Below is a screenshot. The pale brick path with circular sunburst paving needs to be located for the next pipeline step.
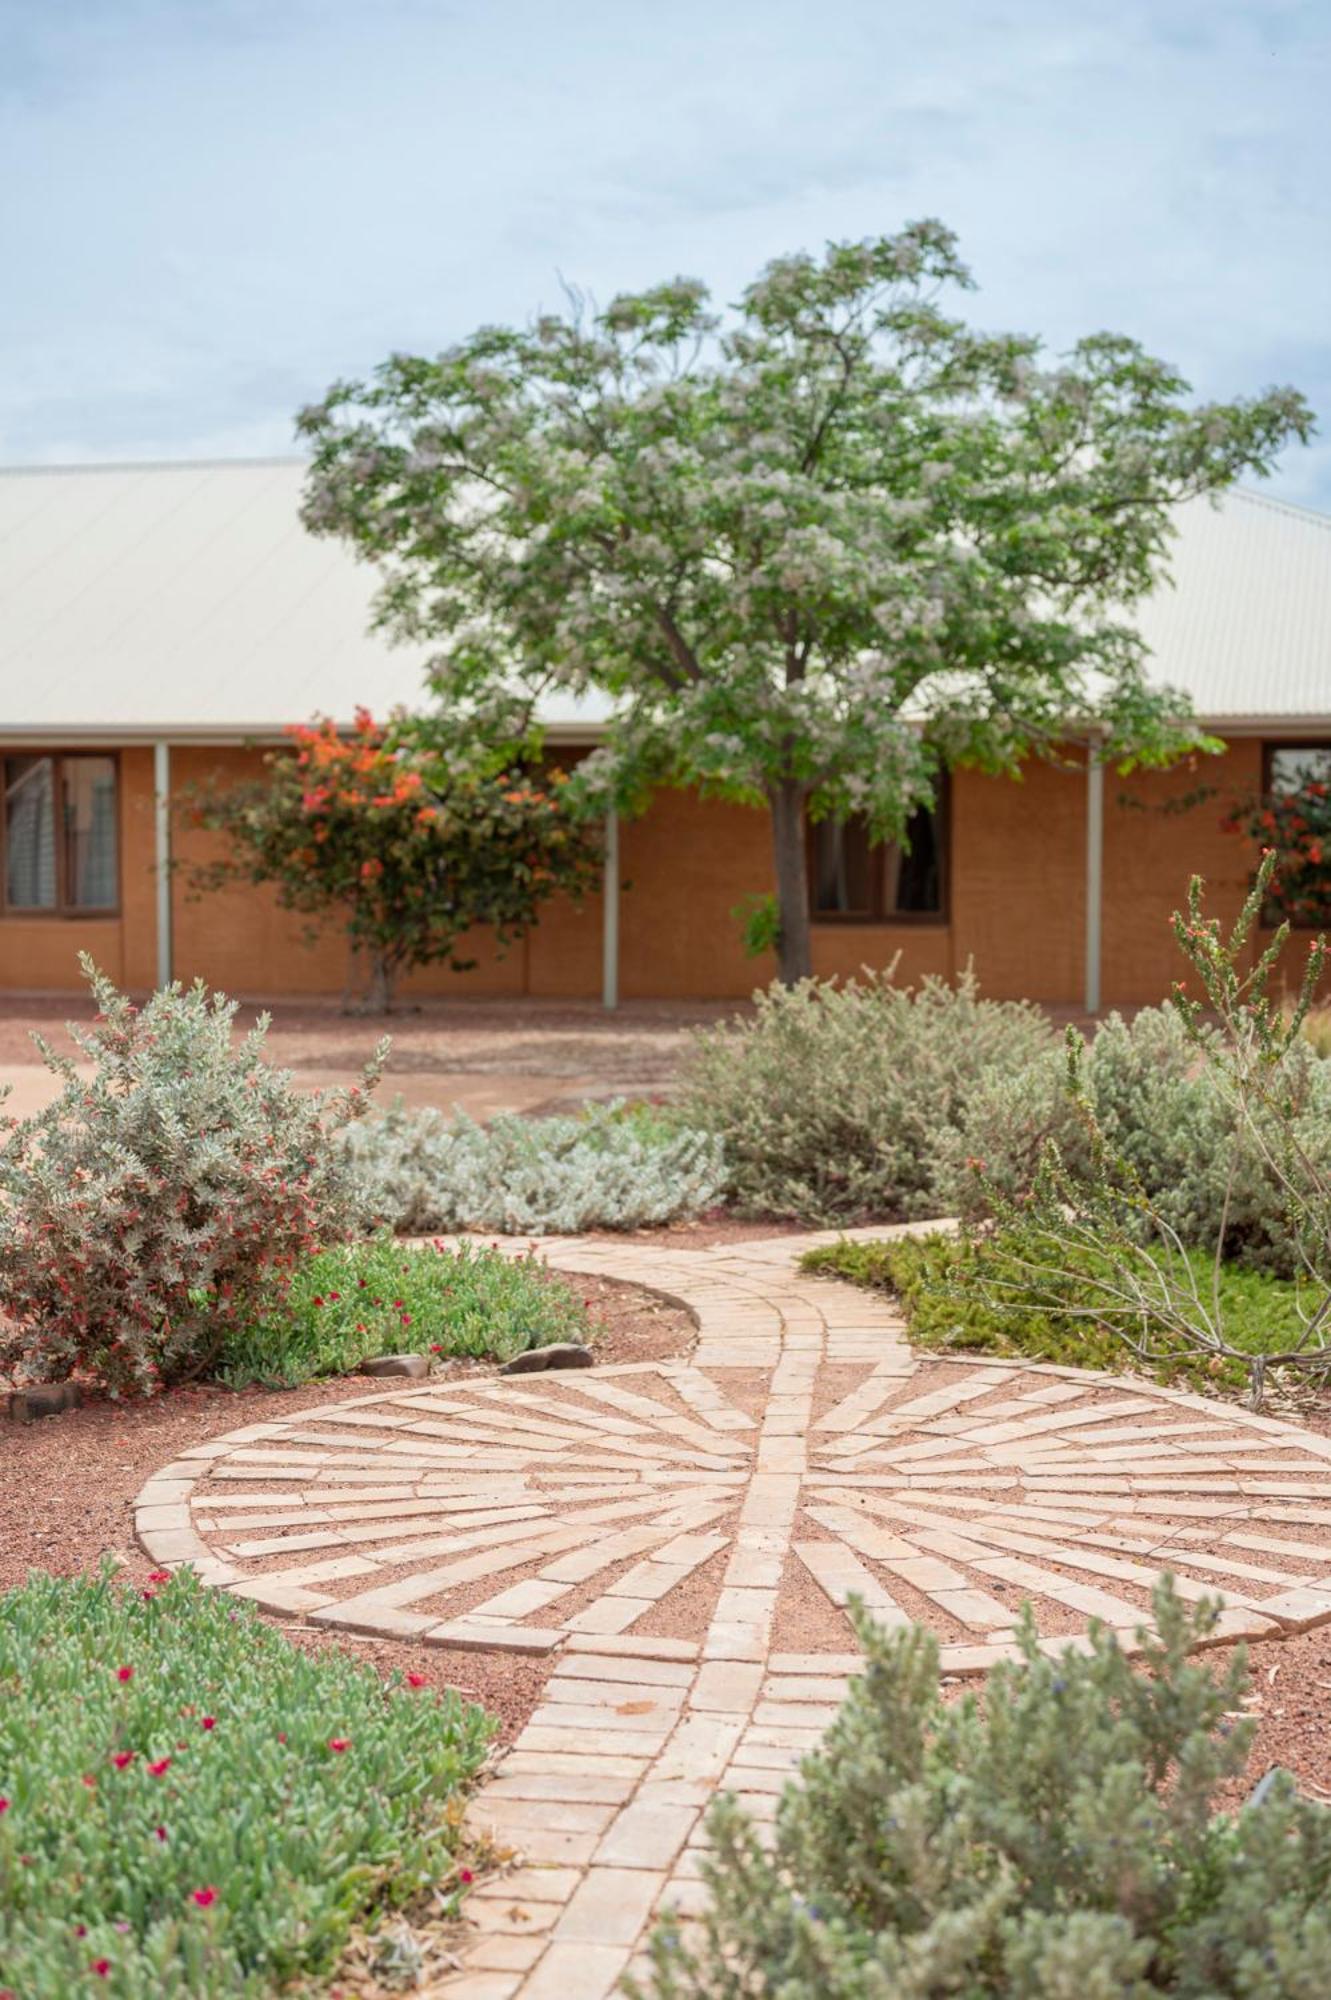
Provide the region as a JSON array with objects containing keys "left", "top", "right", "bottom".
[{"left": 129, "top": 1230, "right": 1331, "bottom": 2000}]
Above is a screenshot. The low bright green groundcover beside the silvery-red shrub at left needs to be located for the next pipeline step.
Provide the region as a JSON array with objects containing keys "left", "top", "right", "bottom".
[{"left": 216, "top": 1236, "right": 592, "bottom": 1388}]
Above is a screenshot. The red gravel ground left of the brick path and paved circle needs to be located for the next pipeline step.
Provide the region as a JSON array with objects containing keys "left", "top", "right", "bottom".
[{"left": 0, "top": 1278, "right": 695, "bottom": 1742}]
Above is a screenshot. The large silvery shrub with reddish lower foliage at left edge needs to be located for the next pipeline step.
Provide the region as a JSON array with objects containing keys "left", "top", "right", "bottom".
[{"left": 0, "top": 958, "right": 384, "bottom": 1396}]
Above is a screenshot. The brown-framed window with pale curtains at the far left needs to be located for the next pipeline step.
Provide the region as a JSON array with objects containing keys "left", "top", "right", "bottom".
[{"left": 4, "top": 752, "right": 120, "bottom": 916}]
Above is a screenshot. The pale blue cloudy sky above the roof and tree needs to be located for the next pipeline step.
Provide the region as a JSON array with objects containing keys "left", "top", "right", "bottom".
[{"left": 0, "top": 0, "right": 1331, "bottom": 512}]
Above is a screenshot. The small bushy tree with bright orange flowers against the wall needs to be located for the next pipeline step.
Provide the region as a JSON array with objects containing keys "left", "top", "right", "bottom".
[{"left": 190, "top": 708, "right": 596, "bottom": 1014}]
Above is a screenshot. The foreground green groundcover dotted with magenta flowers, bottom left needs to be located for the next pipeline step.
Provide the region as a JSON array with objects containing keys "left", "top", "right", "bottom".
[{"left": 0, "top": 1574, "right": 492, "bottom": 2000}]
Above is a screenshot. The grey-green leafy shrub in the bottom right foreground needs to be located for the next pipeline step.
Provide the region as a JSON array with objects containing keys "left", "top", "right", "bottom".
[{"left": 631, "top": 1580, "right": 1331, "bottom": 2000}]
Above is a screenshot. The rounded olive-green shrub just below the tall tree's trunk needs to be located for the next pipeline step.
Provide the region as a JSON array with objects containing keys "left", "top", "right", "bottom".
[{"left": 681, "top": 972, "right": 1053, "bottom": 1224}]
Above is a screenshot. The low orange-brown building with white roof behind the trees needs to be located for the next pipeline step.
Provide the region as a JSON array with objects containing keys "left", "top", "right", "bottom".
[{"left": 0, "top": 460, "right": 1331, "bottom": 1012}]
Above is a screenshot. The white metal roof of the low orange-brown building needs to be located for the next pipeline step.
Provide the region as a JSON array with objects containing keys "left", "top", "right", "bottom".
[{"left": 0, "top": 460, "right": 1331, "bottom": 740}]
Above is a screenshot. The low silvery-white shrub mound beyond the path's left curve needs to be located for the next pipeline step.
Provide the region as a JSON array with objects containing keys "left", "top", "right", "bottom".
[{"left": 342, "top": 1104, "right": 725, "bottom": 1236}]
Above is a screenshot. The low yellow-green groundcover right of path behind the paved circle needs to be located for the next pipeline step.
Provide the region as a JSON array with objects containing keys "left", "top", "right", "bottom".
[{"left": 801, "top": 1228, "right": 1303, "bottom": 1390}]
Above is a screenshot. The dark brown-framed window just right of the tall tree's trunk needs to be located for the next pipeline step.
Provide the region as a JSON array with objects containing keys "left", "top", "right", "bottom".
[{"left": 809, "top": 800, "right": 945, "bottom": 924}]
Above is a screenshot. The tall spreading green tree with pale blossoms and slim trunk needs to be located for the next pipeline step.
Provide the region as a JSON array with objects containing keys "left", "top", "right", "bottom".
[{"left": 300, "top": 222, "right": 1311, "bottom": 980}]
